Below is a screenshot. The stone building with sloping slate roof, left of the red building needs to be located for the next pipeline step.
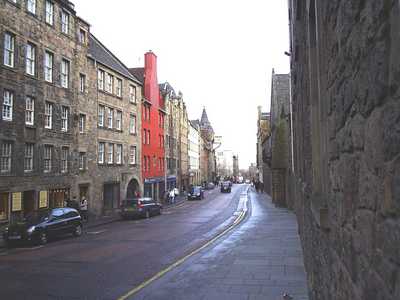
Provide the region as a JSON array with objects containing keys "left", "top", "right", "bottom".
[{"left": 74, "top": 33, "right": 143, "bottom": 215}]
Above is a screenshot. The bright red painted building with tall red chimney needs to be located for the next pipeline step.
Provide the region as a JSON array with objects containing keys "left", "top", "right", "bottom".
[{"left": 130, "top": 51, "right": 166, "bottom": 199}]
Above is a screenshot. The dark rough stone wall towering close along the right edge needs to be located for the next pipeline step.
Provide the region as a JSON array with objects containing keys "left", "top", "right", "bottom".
[{"left": 289, "top": 0, "right": 400, "bottom": 300}]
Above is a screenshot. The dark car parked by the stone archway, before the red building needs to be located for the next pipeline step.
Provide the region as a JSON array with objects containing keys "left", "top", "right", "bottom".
[{"left": 121, "top": 197, "right": 162, "bottom": 219}]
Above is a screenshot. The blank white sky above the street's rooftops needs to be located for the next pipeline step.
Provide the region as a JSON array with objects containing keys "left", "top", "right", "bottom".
[{"left": 72, "top": 0, "right": 289, "bottom": 168}]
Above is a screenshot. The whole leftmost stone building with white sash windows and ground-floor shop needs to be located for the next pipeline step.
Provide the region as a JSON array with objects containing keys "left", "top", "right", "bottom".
[{"left": 0, "top": 0, "right": 81, "bottom": 223}]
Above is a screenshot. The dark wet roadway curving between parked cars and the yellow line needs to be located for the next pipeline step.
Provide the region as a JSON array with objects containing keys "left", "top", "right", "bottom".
[{"left": 0, "top": 185, "right": 246, "bottom": 300}]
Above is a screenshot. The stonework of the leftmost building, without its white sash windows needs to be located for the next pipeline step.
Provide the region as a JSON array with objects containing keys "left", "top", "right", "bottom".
[{"left": 0, "top": 1, "right": 76, "bottom": 220}]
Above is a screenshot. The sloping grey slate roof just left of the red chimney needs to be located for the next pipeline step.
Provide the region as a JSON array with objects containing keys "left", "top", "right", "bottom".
[{"left": 89, "top": 34, "right": 140, "bottom": 83}]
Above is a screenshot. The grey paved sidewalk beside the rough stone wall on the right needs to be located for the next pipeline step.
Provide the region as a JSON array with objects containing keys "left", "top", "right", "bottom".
[{"left": 130, "top": 192, "right": 308, "bottom": 300}]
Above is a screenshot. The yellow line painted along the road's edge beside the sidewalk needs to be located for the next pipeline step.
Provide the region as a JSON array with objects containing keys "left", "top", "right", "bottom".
[{"left": 118, "top": 211, "right": 246, "bottom": 300}]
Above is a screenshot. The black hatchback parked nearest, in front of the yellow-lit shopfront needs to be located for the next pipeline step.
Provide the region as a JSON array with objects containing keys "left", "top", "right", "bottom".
[{"left": 3, "top": 207, "right": 82, "bottom": 245}]
